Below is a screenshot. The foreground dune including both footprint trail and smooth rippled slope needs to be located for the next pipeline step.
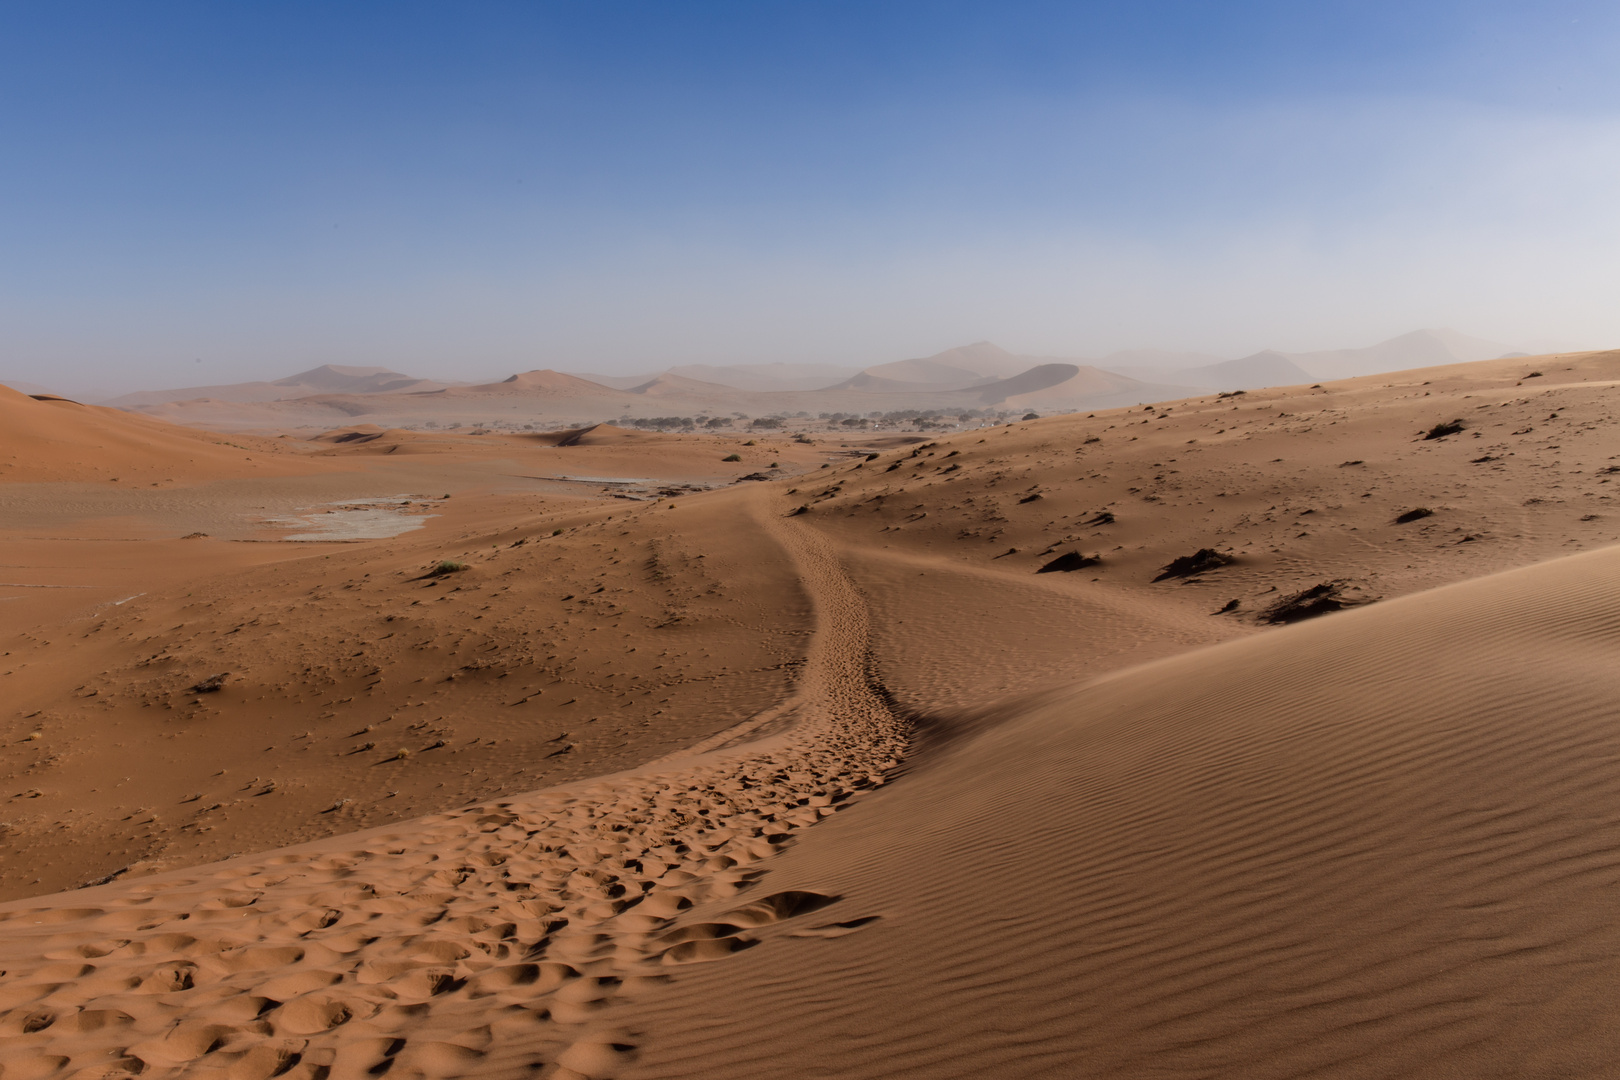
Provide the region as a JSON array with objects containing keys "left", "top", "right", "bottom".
[{"left": 9, "top": 525, "right": 1620, "bottom": 1080}]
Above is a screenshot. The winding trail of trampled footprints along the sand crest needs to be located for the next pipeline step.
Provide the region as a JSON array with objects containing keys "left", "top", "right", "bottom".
[{"left": 0, "top": 499, "right": 907, "bottom": 1080}]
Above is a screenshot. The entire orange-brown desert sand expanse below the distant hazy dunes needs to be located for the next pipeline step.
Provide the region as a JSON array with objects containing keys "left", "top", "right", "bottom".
[{"left": 0, "top": 353, "right": 1620, "bottom": 1080}]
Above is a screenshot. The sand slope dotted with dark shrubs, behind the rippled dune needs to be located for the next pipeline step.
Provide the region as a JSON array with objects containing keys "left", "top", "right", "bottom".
[{"left": 787, "top": 353, "right": 1620, "bottom": 711}]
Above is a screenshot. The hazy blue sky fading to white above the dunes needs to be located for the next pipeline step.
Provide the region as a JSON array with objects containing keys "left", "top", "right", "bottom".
[{"left": 0, "top": 0, "right": 1620, "bottom": 390}]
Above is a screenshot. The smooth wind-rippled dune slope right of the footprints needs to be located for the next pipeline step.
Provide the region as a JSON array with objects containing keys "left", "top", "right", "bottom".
[{"left": 612, "top": 549, "right": 1620, "bottom": 1077}]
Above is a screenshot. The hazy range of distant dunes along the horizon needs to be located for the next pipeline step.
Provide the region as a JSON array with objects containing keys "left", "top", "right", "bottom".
[{"left": 101, "top": 330, "right": 1542, "bottom": 431}]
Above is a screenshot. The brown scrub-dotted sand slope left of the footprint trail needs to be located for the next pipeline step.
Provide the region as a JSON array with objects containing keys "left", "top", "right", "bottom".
[{"left": 0, "top": 484, "right": 810, "bottom": 895}]
